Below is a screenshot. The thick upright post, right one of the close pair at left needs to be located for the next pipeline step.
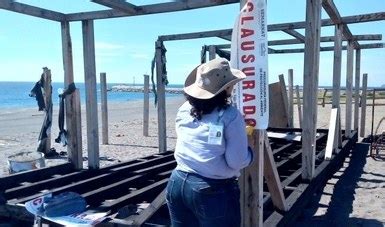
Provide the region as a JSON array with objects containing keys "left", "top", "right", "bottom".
[{"left": 82, "top": 20, "right": 99, "bottom": 169}]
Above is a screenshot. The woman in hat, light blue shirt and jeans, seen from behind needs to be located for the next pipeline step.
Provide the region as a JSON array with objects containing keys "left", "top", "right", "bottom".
[{"left": 166, "top": 58, "right": 253, "bottom": 227}]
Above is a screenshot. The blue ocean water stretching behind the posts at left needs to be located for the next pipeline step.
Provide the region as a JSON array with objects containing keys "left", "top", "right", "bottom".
[{"left": 0, "top": 82, "right": 181, "bottom": 109}]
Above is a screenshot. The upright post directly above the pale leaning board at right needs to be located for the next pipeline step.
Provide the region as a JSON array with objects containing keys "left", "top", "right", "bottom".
[{"left": 332, "top": 24, "right": 342, "bottom": 108}]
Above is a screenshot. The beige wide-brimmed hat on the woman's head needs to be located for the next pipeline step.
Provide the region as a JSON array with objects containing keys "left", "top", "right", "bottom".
[{"left": 184, "top": 58, "right": 246, "bottom": 99}]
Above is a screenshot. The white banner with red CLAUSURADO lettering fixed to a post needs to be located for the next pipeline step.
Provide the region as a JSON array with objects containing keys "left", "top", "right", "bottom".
[{"left": 231, "top": 0, "right": 269, "bottom": 129}]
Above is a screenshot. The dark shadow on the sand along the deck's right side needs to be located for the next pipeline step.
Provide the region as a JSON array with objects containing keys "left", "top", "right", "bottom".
[{"left": 290, "top": 143, "right": 383, "bottom": 227}]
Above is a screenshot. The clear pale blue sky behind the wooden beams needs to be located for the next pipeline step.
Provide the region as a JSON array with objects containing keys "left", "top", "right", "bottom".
[{"left": 0, "top": 0, "right": 385, "bottom": 86}]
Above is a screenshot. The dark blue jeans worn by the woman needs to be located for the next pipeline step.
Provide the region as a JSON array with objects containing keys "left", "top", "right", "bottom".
[{"left": 166, "top": 170, "right": 241, "bottom": 227}]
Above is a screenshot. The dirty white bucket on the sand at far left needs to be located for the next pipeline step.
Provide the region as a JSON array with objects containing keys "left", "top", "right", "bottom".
[{"left": 8, "top": 151, "right": 45, "bottom": 173}]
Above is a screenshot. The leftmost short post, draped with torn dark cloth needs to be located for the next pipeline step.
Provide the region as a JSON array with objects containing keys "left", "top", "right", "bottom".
[{"left": 43, "top": 67, "right": 53, "bottom": 153}]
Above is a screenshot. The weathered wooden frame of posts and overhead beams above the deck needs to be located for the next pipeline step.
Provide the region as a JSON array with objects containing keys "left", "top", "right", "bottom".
[{"left": 0, "top": 0, "right": 385, "bottom": 226}]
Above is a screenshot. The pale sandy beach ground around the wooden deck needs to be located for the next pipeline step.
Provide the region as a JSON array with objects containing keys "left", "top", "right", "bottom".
[{"left": 0, "top": 96, "right": 385, "bottom": 226}]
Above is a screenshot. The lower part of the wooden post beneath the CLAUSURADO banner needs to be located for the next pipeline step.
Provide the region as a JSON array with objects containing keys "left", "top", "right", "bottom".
[{"left": 239, "top": 130, "right": 265, "bottom": 227}]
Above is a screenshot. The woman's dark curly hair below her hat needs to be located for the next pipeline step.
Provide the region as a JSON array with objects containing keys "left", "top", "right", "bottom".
[{"left": 184, "top": 91, "right": 230, "bottom": 120}]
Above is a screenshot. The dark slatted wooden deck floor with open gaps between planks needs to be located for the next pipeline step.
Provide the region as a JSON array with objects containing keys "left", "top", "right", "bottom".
[{"left": 0, "top": 128, "right": 357, "bottom": 226}]
